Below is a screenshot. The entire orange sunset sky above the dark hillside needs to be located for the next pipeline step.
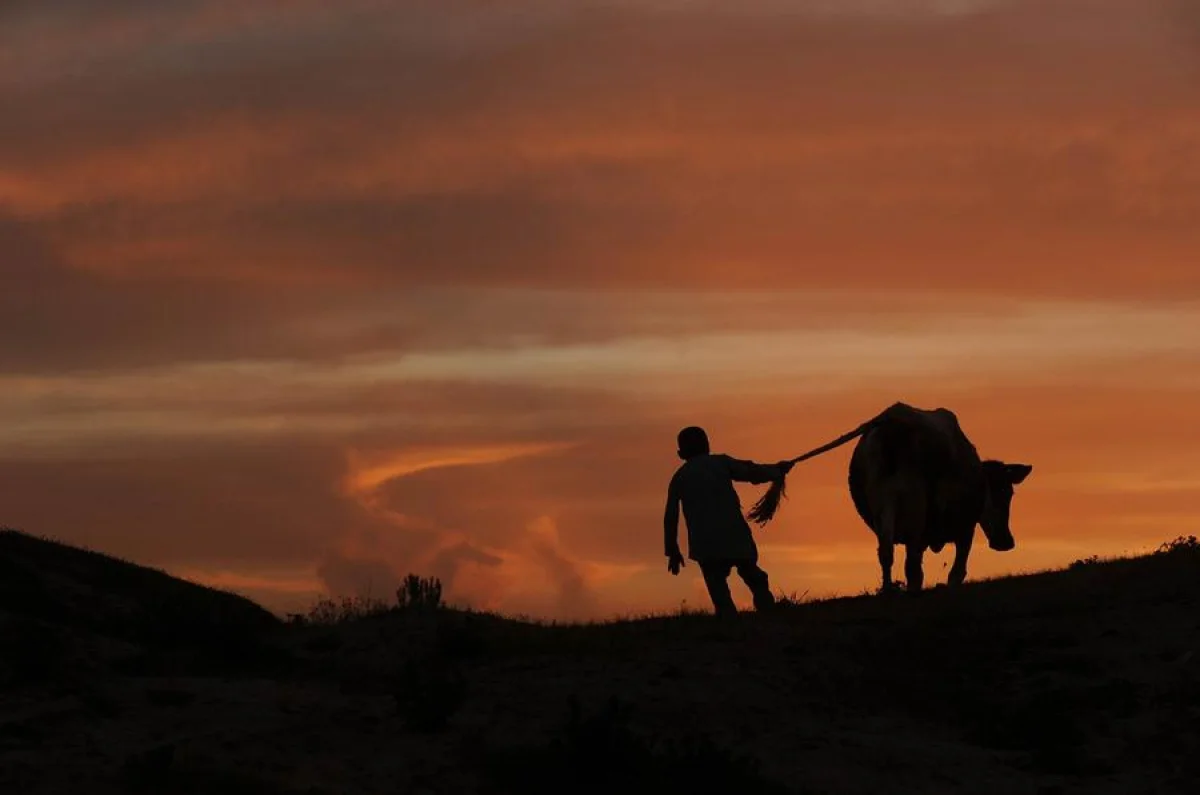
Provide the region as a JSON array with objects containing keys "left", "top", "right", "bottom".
[{"left": 0, "top": 0, "right": 1200, "bottom": 620}]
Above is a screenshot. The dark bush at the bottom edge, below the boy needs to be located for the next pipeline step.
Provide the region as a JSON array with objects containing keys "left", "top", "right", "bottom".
[{"left": 484, "top": 697, "right": 788, "bottom": 795}]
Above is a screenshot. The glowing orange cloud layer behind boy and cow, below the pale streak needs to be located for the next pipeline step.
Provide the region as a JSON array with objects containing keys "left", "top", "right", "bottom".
[{"left": 0, "top": 363, "right": 1200, "bottom": 617}]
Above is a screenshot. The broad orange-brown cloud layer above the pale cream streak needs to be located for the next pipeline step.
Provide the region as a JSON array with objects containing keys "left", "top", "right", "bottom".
[{"left": 0, "top": 2, "right": 1200, "bottom": 302}]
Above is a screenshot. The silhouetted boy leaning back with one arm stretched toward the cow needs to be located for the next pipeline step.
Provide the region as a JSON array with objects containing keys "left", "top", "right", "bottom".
[{"left": 664, "top": 426, "right": 792, "bottom": 615}]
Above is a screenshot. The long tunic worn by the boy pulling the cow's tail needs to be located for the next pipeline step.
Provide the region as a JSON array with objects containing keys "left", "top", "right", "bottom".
[{"left": 664, "top": 453, "right": 782, "bottom": 562}]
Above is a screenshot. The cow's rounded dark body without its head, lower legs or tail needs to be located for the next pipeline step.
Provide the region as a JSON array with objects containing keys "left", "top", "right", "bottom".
[{"left": 850, "top": 404, "right": 983, "bottom": 549}]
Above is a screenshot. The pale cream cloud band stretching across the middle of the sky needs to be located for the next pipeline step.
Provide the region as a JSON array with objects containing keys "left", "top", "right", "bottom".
[{"left": 9, "top": 291, "right": 1198, "bottom": 422}]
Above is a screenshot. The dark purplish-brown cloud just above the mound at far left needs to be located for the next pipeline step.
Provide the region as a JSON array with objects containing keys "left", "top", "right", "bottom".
[{"left": 0, "top": 441, "right": 364, "bottom": 569}]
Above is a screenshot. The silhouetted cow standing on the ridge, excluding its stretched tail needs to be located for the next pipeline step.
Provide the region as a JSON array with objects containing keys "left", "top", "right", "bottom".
[{"left": 844, "top": 402, "right": 1033, "bottom": 593}]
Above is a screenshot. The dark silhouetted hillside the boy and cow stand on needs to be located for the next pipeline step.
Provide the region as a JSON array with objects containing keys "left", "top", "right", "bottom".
[{"left": 0, "top": 528, "right": 1200, "bottom": 795}]
